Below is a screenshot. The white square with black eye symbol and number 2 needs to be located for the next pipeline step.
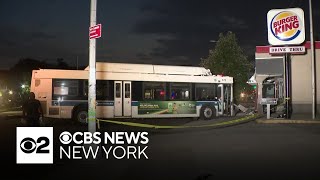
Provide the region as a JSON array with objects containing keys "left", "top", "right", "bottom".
[{"left": 16, "top": 127, "right": 53, "bottom": 164}]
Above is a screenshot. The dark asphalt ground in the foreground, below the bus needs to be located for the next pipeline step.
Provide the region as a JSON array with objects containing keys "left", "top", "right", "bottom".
[{"left": 0, "top": 108, "right": 320, "bottom": 180}]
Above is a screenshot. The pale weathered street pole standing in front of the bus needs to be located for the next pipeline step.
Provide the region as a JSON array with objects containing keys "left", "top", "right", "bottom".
[{"left": 88, "top": 0, "right": 97, "bottom": 133}]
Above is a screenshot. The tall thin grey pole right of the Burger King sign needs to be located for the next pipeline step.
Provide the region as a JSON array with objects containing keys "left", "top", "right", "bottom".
[{"left": 309, "top": 0, "right": 316, "bottom": 119}]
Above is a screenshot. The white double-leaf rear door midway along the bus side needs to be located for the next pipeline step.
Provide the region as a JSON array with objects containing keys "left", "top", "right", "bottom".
[{"left": 114, "top": 81, "right": 131, "bottom": 117}]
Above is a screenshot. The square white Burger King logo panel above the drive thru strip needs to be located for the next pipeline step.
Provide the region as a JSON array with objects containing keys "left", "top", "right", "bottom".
[{"left": 267, "top": 8, "right": 305, "bottom": 45}]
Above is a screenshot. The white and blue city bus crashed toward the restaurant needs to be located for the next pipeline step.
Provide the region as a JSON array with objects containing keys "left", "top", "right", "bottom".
[{"left": 30, "top": 62, "right": 233, "bottom": 123}]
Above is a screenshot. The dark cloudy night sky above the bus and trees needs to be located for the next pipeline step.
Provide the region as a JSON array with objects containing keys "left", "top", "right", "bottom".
[{"left": 0, "top": 0, "right": 320, "bottom": 69}]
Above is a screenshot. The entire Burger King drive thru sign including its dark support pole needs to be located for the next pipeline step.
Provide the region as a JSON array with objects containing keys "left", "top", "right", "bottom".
[{"left": 267, "top": 8, "right": 305, "bottom": 119}]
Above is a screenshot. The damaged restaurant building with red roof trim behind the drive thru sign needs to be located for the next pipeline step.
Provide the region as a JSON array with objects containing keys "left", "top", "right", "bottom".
[{"left": 252, "top": 41, "right": 320, "bottom": 114}]
